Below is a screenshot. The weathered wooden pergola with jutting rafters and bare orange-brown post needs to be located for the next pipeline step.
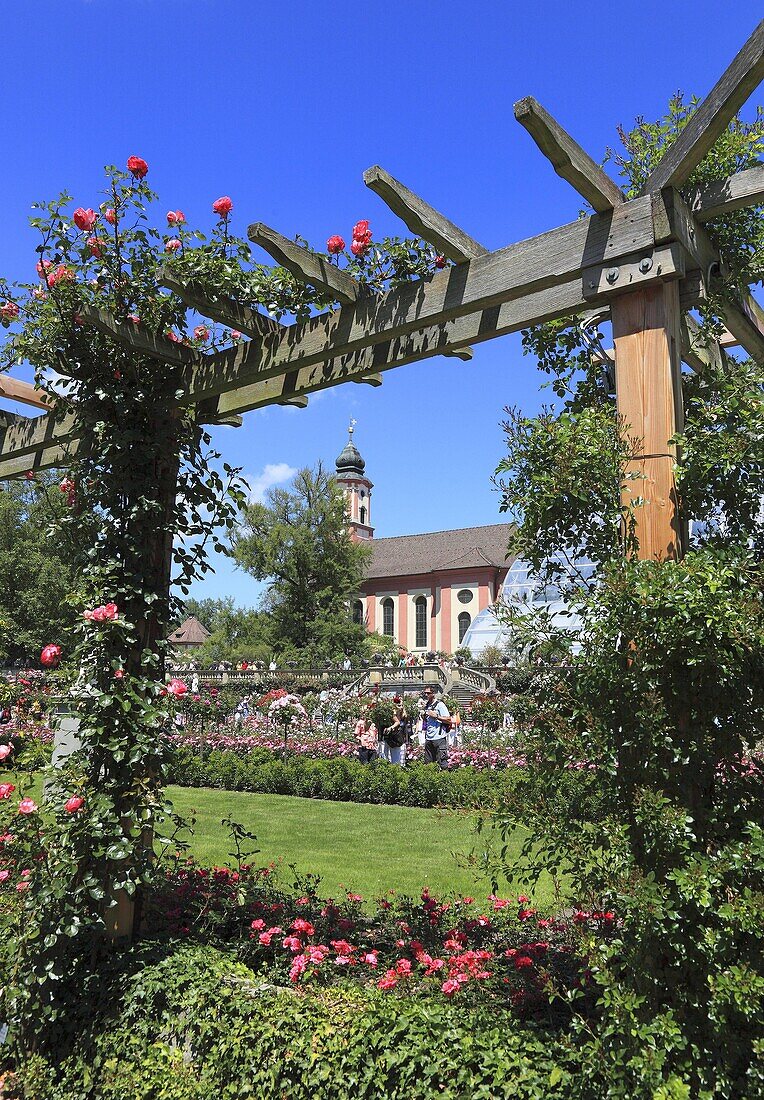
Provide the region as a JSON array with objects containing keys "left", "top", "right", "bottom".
[{"left": 0, "top": 21, "right": 764, "bottom": 560}]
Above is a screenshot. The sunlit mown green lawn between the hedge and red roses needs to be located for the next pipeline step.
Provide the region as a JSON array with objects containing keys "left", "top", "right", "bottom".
[{"left": 13, "top": 780, "right": 553, "bottom": 905}]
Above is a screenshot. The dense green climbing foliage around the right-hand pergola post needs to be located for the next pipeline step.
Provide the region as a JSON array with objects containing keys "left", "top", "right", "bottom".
[{"left": 490, "top": 99, "right": 764, "bottom": 1098}]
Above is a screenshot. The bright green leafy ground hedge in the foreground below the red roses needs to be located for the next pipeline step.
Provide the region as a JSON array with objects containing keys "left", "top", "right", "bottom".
[{"left": 18, "top": 946, "right": 584, "bottom": 1100}]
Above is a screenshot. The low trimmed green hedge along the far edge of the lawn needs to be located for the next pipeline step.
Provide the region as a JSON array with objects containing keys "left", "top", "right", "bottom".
[{"left": 168, "top": 749, "right": 522, "bottom": 810}]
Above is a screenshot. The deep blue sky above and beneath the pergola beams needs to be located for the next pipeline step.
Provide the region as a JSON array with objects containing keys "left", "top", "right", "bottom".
[{"left": 0, "top": 0, "right": 761, "bottom": 604}]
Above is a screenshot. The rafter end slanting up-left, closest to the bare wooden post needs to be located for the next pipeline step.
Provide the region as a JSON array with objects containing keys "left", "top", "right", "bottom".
[{"left": 514, "top": 96, "right": 623, "bottom": 213}]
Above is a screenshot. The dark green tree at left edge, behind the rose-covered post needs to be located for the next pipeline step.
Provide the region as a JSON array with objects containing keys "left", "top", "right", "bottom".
[{"left": 0, "top": 475, "right": 76, "bottom": 663}]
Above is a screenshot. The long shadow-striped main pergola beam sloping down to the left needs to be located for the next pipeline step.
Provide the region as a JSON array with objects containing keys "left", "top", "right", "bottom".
[{"left": 184, "top": 197, "right": 660, "bottom": 402}]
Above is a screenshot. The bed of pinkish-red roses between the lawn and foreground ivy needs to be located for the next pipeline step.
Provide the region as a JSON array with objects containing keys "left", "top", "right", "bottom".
[{"left": 141, "top": 859, "right": 616, "bottom": 1015}]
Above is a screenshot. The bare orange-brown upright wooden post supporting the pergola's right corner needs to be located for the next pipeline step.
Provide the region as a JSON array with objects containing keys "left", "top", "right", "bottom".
[{"left": 610, "top": 281, "right": 686, "bottom": 561}]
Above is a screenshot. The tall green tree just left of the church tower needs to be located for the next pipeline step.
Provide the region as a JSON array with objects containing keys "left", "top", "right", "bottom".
[{"left": 233, "top": 463, "right": 370, "bottom": 660}]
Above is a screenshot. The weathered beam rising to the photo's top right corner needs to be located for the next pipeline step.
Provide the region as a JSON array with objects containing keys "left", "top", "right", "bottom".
[{"left": 642, "top": 20, "right": 764, "bottom": 195}]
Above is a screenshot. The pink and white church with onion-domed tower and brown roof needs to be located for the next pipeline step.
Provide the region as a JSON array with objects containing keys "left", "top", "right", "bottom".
[{"left": 335, "top": 425, "right": 512, "bottom": 653}]
